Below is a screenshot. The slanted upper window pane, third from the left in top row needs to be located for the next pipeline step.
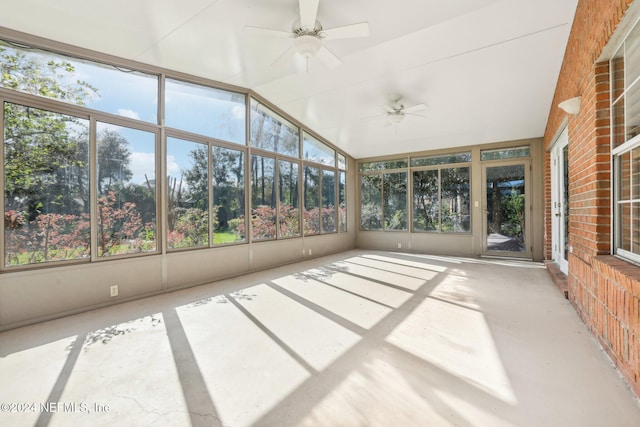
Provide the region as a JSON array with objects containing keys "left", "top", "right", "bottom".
[{"left": 251, "top": 99, "right": 300, "bottom": 157}]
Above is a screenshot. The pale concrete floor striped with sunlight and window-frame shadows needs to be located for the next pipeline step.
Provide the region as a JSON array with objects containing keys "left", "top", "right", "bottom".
[{"left": 0, "top": 251, "right": 640, "bottom": 427}]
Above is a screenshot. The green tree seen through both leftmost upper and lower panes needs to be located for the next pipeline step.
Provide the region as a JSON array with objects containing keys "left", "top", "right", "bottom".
[{"left": 0, "top": 45, "right": 97, "bottom": 220}]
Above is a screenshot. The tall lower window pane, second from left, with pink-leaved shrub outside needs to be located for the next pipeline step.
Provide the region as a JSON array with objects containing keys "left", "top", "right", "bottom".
[{"left": 96, "top": 123, "right": 156, "bottom": 256}]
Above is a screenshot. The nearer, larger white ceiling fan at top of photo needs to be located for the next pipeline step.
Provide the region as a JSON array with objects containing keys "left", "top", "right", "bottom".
[{"left": 245, "top": 0, "right": 369, "bottom": 68}]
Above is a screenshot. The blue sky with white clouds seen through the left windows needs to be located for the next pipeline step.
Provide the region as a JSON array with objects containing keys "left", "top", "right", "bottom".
[{"left": 0, "top": 44, "right": 340, "bottom": 189}]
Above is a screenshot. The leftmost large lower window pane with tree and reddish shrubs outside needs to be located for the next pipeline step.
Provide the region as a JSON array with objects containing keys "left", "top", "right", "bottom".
[{"left": 4, "top": 103, "right": 90, "bottom": 266}]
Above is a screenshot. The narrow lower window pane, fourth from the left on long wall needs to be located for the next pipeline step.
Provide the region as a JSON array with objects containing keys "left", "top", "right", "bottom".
[{"left": 211, "top": 146, "right": 246, "bottom": 245}]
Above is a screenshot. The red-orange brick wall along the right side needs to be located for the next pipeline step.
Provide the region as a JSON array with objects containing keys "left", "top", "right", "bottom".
[{"left": 544, "top": 0, "right": 640, "bottom": 396}]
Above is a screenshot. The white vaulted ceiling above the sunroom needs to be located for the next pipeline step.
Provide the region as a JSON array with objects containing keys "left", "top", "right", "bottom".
[{"left": 0, "top": 0, "right": 578, "bottom": 158}]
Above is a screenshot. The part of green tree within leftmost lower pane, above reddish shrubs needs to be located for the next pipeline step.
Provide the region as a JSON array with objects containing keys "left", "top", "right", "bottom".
[{"left": 4, "top": 103, "right": 89, "bottom": 220}]
